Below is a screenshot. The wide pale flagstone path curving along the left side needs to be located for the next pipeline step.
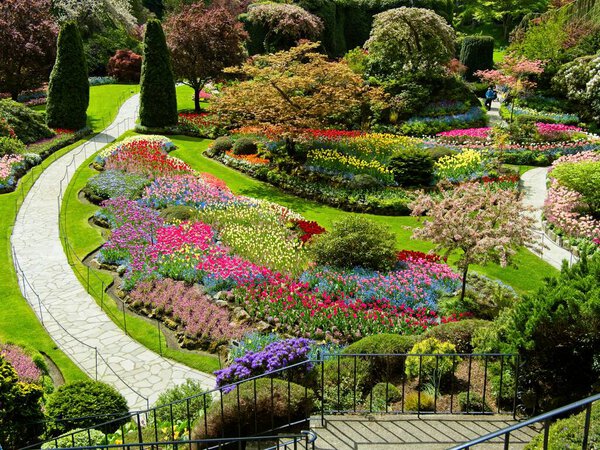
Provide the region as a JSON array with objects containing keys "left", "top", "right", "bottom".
[{"left": 11, "top": 95, "right": 215, "bottom": 410}]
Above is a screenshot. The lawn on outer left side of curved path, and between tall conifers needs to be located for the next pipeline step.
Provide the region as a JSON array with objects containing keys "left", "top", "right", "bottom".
[{"left": 0, "top": 85, "right": 135, "bottom": 382}]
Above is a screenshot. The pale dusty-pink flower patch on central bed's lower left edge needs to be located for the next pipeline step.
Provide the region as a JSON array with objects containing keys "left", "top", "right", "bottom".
[{"left": 130, "top": 278, "right": 249, "bottom": 343}]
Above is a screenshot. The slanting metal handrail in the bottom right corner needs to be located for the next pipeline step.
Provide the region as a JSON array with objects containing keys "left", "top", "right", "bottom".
[{"left": 451, "top": 394, "right": 600, "bottom": 450}]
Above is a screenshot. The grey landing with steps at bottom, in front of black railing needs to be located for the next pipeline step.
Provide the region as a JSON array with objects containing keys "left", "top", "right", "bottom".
[{"left": 311, "top": 414, "right": 537, "bottom": 450}]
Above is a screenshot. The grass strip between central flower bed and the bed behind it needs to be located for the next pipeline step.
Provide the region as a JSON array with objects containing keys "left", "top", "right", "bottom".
[{"left": 166, "top": 136, "right": 558, "bottom": 294}]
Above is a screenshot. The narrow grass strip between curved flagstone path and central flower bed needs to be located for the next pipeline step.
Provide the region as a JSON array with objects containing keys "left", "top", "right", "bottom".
[{"left": 60, "top": 133, "right": 220, "bottom": 373}]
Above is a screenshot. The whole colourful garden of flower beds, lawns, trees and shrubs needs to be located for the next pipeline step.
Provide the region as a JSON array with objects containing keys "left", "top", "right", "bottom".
[{"left": 0, "top": 0, "right": 600, "bottom": 448}]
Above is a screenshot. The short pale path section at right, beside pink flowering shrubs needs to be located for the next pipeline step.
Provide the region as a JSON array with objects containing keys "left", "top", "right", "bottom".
[{"left": 521, "top": 167, "right": 578, "bottom": 269}]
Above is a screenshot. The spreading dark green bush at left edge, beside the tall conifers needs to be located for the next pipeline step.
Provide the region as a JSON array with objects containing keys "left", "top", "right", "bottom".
[{"left": 0, "top": 99, "right": 54, "bottom": 144}]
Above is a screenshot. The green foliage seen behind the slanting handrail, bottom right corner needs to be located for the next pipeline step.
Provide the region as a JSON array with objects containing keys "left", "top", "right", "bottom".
[{"left": 525, "top": 402, "right": 600, "bottom": 450}]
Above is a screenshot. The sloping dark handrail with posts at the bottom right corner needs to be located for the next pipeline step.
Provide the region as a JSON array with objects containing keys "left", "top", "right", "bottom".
[{"left": 450, "top": 394, "right": 600, "bottom": 450}]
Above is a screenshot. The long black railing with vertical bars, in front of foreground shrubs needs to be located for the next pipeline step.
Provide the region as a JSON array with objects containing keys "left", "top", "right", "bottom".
[{"left": 25, "top": 353, "right": 520, "bottom": 449}]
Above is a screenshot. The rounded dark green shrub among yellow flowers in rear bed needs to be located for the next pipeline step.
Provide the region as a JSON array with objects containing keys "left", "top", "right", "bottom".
[{"left": 389, "top": 149, "right": 434, "bottom": 186}]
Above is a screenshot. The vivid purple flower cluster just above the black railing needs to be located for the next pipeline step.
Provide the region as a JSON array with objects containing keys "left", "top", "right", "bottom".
[{"left": 215, "top": 338, "right": 311, "bottom": 392}]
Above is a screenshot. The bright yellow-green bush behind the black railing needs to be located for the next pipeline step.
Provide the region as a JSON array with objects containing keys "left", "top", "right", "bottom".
[{"left": 405, "top": 338, "right": 460, "bottom": 386}]
